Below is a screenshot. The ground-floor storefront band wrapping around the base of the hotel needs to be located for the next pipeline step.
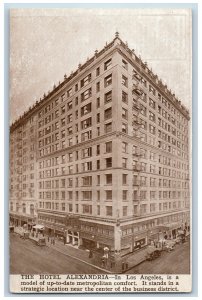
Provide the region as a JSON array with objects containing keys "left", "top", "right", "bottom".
[{"left": 38, "top": 211, "right": 190, "bottom": 255}]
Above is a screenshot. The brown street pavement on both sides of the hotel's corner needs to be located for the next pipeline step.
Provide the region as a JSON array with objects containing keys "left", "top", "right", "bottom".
[{"left": 10, "top": 234, "right": 190, "bottom": 274}]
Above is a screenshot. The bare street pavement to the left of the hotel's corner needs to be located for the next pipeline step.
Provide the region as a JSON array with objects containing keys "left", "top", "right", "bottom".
[{"left": 10, "top": 234, "right": 106, "bottom": 274}]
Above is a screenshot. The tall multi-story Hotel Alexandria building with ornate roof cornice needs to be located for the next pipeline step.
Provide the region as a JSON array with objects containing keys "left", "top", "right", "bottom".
[{"left": 10, "top": 33, "right": 190, "bottom": 252}]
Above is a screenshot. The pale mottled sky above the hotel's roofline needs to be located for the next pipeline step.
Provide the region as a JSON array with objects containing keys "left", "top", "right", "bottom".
[{"left": 10, "top": 8, "right": 192, "bottom": 122}]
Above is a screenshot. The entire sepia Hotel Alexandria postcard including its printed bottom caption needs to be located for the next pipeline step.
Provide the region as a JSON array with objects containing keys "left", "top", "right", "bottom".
[{"left": 8, "top": 8, "right": 192, "bottom": 293}]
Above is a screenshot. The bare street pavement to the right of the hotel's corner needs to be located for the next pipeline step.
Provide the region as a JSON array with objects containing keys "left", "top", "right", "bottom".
[{"left": 126, "top": 242, "right": 190, "bottom": 274}]
